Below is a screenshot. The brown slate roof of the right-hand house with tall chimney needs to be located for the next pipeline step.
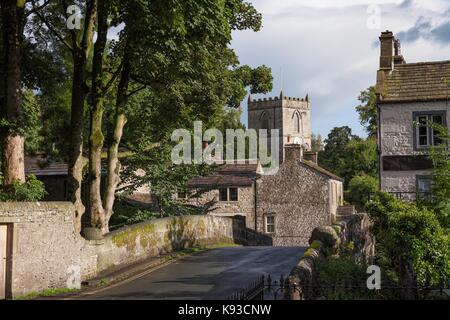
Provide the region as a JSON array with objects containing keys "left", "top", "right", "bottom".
[{"left": 380, "top": 61, "right": 450, "bottom": 103}]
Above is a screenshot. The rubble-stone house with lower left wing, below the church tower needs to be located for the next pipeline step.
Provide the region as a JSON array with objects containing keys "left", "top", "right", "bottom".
[{"left": 181, "top": 144, "right": 343, "bottom": 246}]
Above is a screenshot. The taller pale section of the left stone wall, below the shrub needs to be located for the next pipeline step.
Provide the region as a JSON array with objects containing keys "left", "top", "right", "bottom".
[{"left": 0, "top": 202, "right": 97, "bottom": 296}]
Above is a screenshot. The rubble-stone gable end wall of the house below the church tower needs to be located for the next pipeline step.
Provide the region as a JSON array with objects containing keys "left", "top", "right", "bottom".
[{"left": 257, "top": 159, "right": 342, "bottom": 246}]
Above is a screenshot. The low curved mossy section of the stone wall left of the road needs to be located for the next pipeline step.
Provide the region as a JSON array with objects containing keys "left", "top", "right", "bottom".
[{"left": 91, "top": 215, "right": 239, "bottom": 271}]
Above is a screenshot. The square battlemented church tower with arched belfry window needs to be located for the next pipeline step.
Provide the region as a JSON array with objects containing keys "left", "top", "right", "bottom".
[{"left": 248, "top": 92, "right": 311, "bottom": 163}]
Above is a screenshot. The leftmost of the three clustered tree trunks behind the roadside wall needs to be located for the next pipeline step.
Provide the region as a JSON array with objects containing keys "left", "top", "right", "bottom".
[{"left": 68, "top": 0, "right": 97, "bottom": 232}]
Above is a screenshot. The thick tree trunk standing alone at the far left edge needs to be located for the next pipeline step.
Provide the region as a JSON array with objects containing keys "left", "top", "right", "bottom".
[{"left": 1, "top": 0, "right": 25, "bottom": 187}]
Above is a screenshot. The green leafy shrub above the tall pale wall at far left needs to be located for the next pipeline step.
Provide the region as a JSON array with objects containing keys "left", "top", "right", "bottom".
[{"left": 0, "top": 175, "right": 46, "bottom": 202}]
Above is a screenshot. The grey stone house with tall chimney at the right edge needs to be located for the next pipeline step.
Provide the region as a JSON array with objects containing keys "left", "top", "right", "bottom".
[{"left": 377, "top": 31, "right": 450, "bottom": 200}]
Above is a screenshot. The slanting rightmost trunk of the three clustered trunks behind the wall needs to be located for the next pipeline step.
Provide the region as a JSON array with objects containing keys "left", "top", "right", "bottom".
[{"left": 104, "top": 55, "right": 130, "bottom": 235}]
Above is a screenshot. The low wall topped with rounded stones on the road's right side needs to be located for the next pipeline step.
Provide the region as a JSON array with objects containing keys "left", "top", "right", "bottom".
[{"left": 285, "top": 213, "right": 375, "bottom": 300}]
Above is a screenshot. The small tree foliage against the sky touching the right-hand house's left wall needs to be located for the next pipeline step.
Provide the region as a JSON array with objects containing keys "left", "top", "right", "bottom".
[{"left": 356, "top": 86, "right": 378, "bottom": 137}]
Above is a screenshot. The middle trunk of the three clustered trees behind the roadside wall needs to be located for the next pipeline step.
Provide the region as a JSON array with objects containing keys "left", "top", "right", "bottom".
[{"left": 89, "top": 0, "right": 108, "bottom": 233}]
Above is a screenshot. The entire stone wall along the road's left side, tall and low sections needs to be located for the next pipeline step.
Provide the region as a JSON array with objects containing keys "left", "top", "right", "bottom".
[{"left": 0, "top": 202, "right": 270, "bottom": 298}]
